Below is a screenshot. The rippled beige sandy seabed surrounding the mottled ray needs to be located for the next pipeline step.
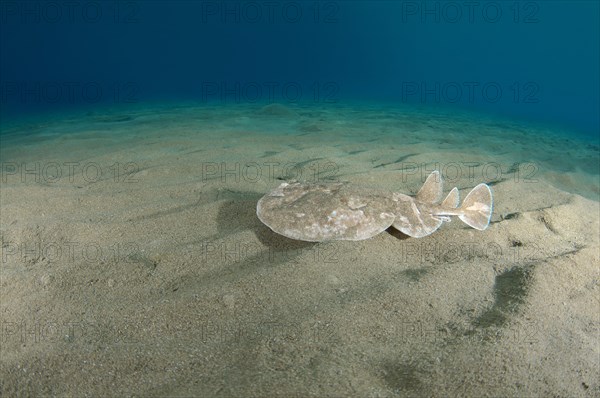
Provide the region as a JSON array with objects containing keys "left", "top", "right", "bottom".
[{"left": 0, "top": 105, "right": 600, "bottom": 397}]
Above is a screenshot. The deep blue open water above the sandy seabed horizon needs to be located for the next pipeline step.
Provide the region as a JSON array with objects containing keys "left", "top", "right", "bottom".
[{"left": 0, "top": 0, "right": 600, "bottom": 135}]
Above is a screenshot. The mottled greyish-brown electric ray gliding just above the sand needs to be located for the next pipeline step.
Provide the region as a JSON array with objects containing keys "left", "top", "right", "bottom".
[{"left": 256, "top": 170, "right": 493, "bottom": 242}]
